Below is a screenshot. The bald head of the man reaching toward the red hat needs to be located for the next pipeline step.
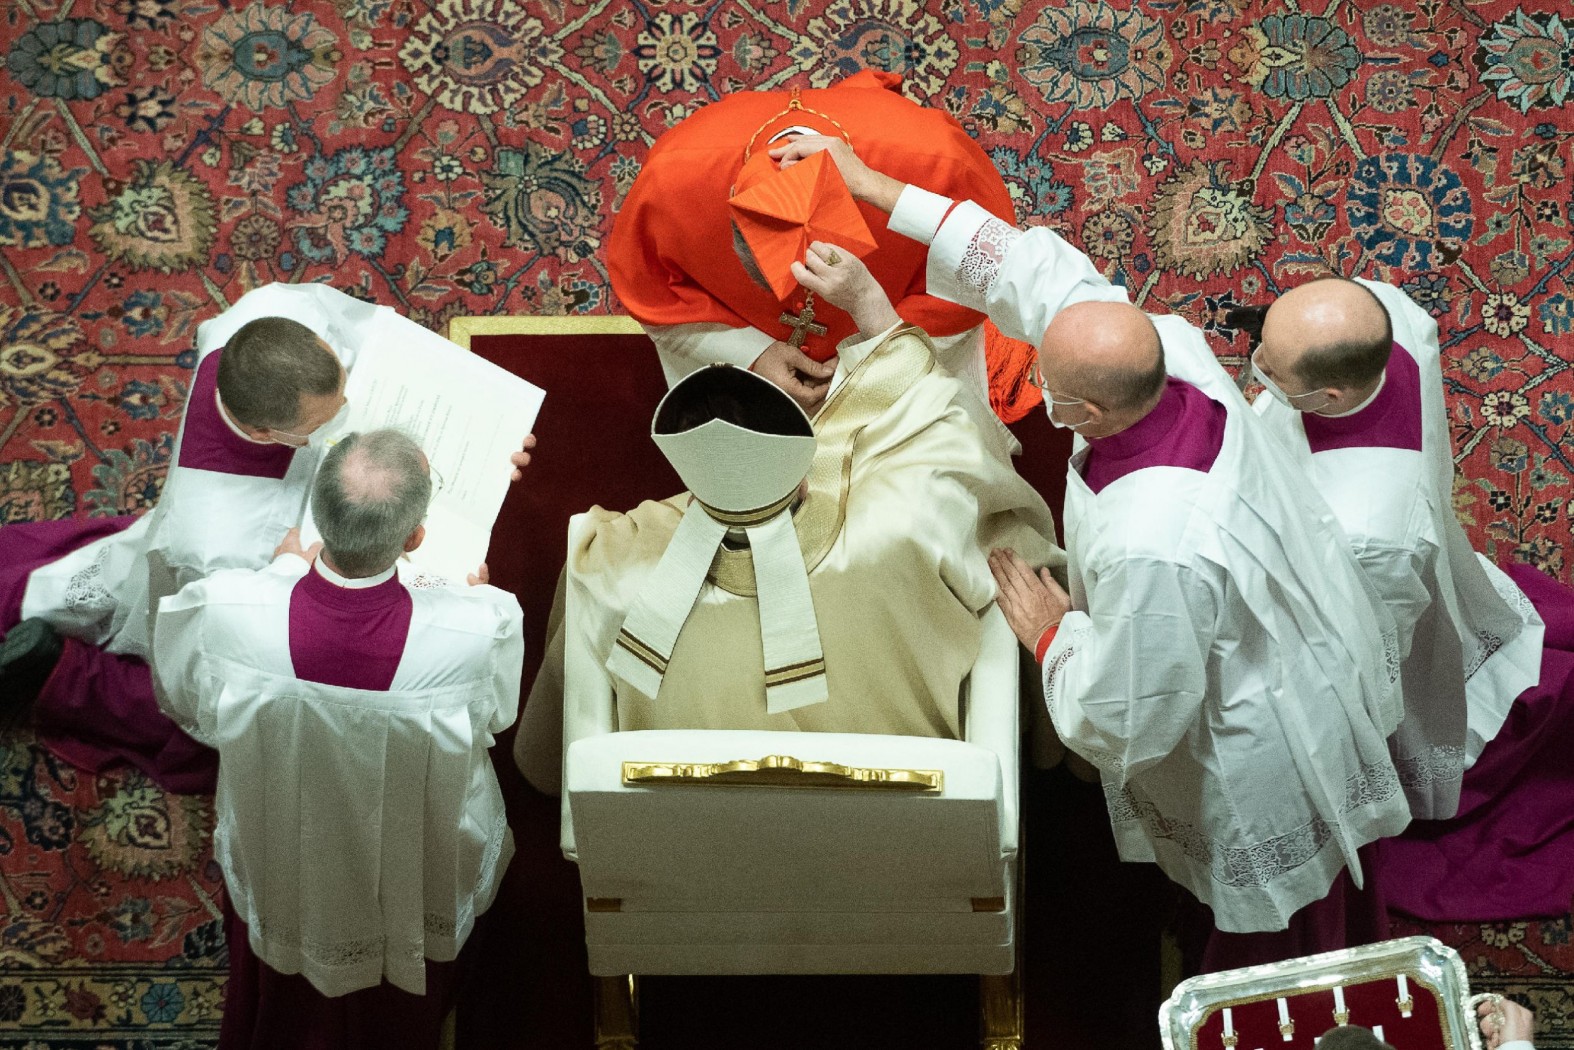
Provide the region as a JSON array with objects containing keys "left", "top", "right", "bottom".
[{"left": 1039, "top": 302, "right": 1165, "bottom": 425}]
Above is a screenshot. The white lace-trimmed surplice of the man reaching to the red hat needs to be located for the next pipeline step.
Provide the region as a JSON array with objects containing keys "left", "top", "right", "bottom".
[{"left": 892, "top": 190, "right": 1409, "bottom": 932}]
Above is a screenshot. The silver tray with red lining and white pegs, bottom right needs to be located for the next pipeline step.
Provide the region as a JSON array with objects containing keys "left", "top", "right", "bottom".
[{"left": 1158, "top": 937, "right": 1492, "bottom": 1050}]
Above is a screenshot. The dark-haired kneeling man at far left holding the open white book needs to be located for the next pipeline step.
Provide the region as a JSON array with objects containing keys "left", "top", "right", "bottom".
[{"left": 0, "top": 283, "right": 534, "bottom": 792}]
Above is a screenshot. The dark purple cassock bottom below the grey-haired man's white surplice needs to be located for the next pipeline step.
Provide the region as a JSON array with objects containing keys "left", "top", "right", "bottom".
[{"left": 219, "top": 894, "right": 460, "bottom": 1050}]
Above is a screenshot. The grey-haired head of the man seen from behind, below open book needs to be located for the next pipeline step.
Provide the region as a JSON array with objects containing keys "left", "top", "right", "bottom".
[{"left": 312, "top": 430, "right": 431, "bottom": 578}]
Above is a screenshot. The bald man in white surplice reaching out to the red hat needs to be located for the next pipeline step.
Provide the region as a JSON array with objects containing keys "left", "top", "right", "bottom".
[{"left": 778, "top": 139, "right": 1409, "bottom": 968}]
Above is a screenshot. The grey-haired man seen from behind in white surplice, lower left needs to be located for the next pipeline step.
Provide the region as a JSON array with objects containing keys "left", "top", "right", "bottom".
[{"left": 156, "top": 430, "right": 524, "bottom": 1050}]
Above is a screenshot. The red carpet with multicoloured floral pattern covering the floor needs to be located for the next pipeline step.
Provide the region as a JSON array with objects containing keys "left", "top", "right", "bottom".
[{"left": 0, "top": 0, "right": 1574, "bottom": 1050}]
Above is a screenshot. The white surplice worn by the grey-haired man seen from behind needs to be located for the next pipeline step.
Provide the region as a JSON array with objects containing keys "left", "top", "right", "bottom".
[{"left": 156, "top": 556, "right": 524, "bottom": 995}]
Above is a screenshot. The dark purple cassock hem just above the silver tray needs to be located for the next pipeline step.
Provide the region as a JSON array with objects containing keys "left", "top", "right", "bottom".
[{"left": 1201, "top": 844, "right": 1388, "bottom": 973}]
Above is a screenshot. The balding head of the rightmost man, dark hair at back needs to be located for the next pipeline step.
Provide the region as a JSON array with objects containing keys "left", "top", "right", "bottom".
[{"left": 1262, "top": 277, "right": 1393, "bottom": 390}]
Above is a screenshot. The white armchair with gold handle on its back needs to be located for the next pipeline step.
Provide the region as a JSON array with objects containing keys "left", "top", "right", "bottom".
[{"left": 562, "top": 516, "right": 1022, "bottom": 1050}]
